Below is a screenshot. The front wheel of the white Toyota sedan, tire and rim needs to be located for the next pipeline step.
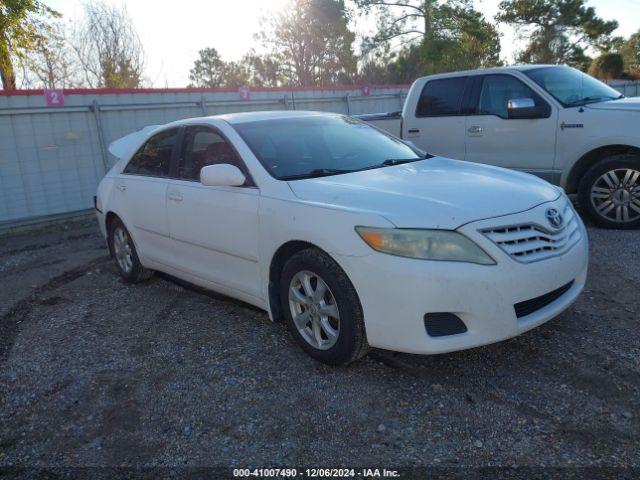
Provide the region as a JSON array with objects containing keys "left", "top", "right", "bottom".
[{"left": 280, "top": 248, "right": 369, "bottom": 365}]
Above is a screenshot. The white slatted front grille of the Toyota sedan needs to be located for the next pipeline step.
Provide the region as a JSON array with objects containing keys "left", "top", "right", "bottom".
[{"left": 481, "top": 202, "right": 580, "bottom": 263}]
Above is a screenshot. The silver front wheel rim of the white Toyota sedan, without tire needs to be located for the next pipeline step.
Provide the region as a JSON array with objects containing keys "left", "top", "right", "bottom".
[{"left": 289, "top": 270, "right": 340, "bottom": 350}]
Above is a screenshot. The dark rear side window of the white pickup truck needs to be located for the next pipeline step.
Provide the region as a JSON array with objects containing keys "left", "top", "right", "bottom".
[{"left": 416, "top": 77, "right": 467, "bottom": 117}]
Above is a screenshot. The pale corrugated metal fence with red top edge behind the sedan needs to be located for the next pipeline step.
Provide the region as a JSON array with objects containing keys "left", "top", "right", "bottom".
[{"left": 0, "top": 85, "right": 408, "bottom": 227}]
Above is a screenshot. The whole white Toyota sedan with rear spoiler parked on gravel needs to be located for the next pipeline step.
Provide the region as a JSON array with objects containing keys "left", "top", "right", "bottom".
[{"left": 95, "top": 112, "right": 588, "bottom": 364}]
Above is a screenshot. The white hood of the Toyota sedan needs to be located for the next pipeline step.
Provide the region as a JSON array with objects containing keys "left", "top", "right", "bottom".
[{"left": 289, "top": 157, "right": 560, "bottom": 229}]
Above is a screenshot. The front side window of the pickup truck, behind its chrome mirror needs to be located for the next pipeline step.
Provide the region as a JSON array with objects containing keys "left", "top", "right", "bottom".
[{"left": 477, "top": 75, "right": 545, "bottom": 118}]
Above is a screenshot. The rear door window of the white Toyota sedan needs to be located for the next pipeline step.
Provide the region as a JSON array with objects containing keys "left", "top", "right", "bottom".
[{"left": 122, "top": 128, "right": 178, "bottom": 177}]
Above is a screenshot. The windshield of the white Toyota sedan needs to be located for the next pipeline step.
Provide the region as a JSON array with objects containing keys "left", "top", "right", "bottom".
[{"left": 233, "top": 115, "right": 426, "bottom": 180}]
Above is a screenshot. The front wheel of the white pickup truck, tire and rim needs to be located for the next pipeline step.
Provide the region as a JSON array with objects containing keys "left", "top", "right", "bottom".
[{"left": 578, "top": 155, "right": 640, "bottom": 228}]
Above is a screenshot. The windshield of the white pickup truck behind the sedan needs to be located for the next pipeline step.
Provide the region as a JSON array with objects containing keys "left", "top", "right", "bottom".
[{"left": 523, "top": 67, "right": 624, "bottom": 107}]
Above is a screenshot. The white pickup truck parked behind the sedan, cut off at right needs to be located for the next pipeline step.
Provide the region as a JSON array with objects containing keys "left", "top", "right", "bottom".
[{"left": 358, "top": 65, "right": 640, "bottom": 228}]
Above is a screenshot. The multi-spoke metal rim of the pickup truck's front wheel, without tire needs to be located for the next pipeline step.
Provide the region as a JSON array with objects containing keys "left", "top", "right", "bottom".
[{"left": 590, "top": 168, "right": 640, "bottom": 223}]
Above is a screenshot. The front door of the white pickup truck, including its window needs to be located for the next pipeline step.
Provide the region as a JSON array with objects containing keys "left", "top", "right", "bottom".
[{"left": 465, "top": 74, "right": 558, "bottom": 181}]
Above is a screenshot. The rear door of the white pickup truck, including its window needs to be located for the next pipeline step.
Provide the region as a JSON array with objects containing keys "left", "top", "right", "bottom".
[{"left": 402, "top": 76, "right": 470, "bottom": 160}]
